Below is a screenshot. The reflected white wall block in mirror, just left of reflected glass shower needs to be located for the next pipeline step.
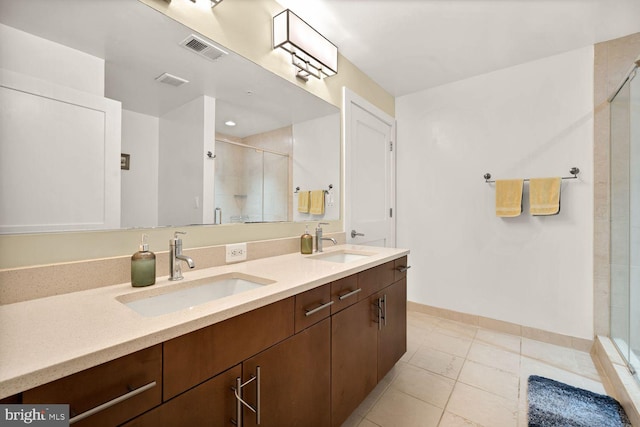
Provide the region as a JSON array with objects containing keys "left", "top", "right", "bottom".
[{"left": 158, "top": 96, "right": 215, "bottom": 225}]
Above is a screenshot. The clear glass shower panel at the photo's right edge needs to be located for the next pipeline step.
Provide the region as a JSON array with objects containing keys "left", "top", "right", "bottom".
[{"left": 609, "top": 58, "right": 640, "bottom": 378}]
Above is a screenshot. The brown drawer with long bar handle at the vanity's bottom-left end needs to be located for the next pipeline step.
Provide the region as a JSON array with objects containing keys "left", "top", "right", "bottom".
[{"left": 23, "top": 344, "right": 162, "bottom": 427}]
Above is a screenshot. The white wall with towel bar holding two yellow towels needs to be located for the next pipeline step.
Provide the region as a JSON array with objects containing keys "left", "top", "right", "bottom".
[{"left": 396, "top": 47, "right": 593, "bottom": 339}]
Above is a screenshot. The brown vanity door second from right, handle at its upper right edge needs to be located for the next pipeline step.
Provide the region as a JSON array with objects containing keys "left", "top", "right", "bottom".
[{"left": 331, "top": 298, "right": 378, "bottom": 426}]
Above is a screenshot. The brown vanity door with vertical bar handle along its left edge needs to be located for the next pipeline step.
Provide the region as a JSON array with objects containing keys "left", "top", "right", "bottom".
[{"left": 242, "top": 319, "right": 331, "bottom": 427}]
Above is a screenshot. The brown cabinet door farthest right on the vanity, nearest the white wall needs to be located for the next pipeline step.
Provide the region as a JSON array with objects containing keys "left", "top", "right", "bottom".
[{"left": 378, "top": 279, "right": 407, "bottom": 381}]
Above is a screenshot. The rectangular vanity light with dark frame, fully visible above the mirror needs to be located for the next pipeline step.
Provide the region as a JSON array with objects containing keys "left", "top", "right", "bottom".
[{"left": 273, "top": 9, "right": 338, "bottom": 81}]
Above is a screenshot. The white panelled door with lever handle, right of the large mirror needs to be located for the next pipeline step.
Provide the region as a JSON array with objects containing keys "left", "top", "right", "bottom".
[{"left": 343, "top": 88, "right": 396, "bottom": 247}]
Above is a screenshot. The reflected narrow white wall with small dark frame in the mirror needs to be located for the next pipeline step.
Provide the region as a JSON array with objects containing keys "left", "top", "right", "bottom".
[{"left": 120, "top": 110, "right": 160, "bottom": 228}]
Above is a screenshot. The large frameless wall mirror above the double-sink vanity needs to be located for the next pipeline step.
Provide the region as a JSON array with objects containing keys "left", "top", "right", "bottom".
[{"left": 0, "top": 0, "right": 340, "bottom": 233}]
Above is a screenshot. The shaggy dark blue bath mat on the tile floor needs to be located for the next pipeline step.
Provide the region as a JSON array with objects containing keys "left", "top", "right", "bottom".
[{"left": 528, "top": 375, "right": 631, "bottom": 427}]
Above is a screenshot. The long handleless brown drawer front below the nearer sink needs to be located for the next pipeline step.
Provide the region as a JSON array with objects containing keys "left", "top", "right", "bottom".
[{"left": 163, "top": 297, "right": 294, "bottom": 400}]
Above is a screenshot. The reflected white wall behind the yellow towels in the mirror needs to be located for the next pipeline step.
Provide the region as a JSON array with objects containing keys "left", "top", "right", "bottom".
[{"left": 293, "top": 114, "right": 341, "bottom": 222}]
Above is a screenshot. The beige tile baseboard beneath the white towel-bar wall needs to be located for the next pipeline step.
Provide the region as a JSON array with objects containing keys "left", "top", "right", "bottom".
[{"left": 407, "top": 301, "right": 593, "bottom": 352}]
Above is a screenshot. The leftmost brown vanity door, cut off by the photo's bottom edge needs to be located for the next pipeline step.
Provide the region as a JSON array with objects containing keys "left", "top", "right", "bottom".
[{"left": 124, "top": 365, "right": 242, "bottom": 427}]
